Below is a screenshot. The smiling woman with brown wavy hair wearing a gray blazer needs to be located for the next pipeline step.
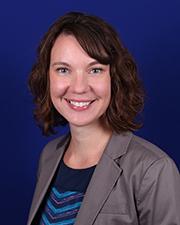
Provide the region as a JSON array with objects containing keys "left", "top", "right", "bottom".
[{"left": 28, "top": 12, "right": 180, "bottom": 225}]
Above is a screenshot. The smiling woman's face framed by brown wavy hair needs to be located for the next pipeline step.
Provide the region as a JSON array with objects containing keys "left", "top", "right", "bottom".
[{"left": 49, "top": 34, "right": 111, "bottom": 126}]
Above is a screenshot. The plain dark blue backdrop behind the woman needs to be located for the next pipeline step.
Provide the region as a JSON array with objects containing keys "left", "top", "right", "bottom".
[{"left": 0, "top": 0, "right": 180, "bottom": 225}]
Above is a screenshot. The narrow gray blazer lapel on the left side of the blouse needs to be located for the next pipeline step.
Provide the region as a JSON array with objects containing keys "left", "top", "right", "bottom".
[{"left": 27, "top": 136, "right": 69, "bottom": 225}]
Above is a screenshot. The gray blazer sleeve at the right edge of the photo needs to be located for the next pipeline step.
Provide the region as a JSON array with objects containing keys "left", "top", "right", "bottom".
[{"left": 137, "top": 157, "right": 180, "bottom": 225}]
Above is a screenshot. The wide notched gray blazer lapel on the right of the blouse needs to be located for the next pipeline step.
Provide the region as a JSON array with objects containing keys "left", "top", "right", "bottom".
[{"left": 75, "top": 132, "right": 132, "bottom": 225}]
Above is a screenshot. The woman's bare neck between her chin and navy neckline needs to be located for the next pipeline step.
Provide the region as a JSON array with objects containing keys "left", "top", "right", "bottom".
[{"left": 64, "top": 124, "right": 112, "bottom": 168}]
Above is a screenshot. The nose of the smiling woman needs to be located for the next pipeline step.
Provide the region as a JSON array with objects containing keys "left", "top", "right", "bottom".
[{"left": 71, "top": 72, "right": 89, "bottom": 94}]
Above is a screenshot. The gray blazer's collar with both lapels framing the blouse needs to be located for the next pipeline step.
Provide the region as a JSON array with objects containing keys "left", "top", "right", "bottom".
[{"left": 27, "top": 132, "right": 133, "bottom": 225}]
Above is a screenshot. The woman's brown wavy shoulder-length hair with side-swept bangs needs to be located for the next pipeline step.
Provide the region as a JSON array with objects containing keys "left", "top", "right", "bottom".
[{"left": 29, "top": 12, "right": 144, "bottom": 135}]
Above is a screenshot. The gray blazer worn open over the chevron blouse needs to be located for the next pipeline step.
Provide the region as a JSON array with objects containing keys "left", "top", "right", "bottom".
[{"left": 27, "top": 132, "right": 180, "bottom": 225}]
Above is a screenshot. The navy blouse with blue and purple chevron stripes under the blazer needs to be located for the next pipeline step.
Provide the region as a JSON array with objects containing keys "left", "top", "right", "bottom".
[{"left": 39, "top": 161, "right": 95, "bottom": 225}]
